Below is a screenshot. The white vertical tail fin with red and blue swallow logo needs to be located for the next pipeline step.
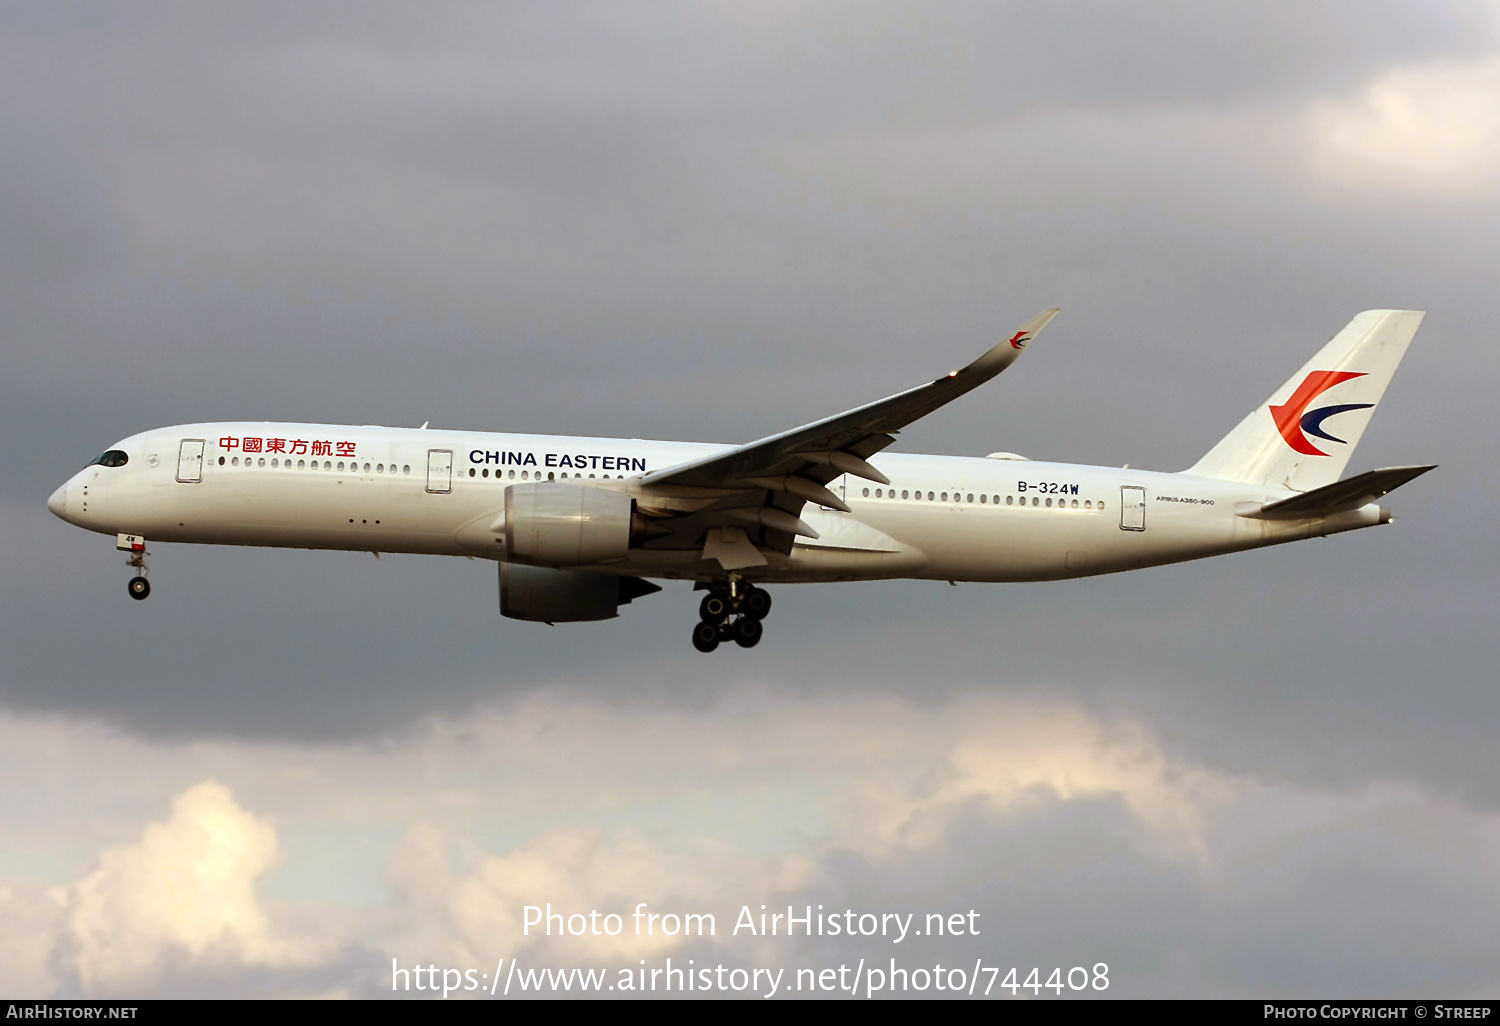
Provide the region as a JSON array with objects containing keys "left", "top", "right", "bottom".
[{"left": 1185, "top": 311, "right": 1424, "bottom": 492}]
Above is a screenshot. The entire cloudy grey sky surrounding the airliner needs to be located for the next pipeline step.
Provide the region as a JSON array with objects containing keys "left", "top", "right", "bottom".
[{"left": 0, "top": 0, "right": 1500, "bottom": 996}]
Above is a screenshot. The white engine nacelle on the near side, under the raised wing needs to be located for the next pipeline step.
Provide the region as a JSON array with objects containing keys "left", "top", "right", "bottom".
[{"left": 506, "top": 482, "right": 635, "bottom": 570}]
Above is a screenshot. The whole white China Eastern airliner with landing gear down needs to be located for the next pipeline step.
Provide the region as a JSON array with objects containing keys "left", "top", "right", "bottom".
[{"left": 48, "top": 309, "right": 1433, "bottom": 653}]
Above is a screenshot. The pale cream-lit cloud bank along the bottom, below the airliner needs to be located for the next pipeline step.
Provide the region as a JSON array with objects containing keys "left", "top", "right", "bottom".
[{"left": 0, "top": 689, "right": 1500, "bottom": 995}]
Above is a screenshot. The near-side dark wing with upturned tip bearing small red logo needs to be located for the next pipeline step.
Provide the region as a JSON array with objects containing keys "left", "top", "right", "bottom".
[{"left": 641, "top": 309, "right": 1058, "bottom": 569}]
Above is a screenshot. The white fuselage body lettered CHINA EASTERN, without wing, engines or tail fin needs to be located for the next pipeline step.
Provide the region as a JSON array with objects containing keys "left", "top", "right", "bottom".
[{"left": 50, "top": 423, "right": 1388, "bottom": 582}]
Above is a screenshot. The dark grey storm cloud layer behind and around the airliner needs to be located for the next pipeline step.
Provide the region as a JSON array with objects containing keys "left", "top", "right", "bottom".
[{"left": 0, "top": 5, "right": 1500, "bottom": 834}]
